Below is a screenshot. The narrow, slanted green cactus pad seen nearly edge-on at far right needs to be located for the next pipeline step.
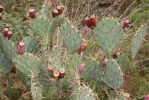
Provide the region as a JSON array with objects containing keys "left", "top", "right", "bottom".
[{"left": 131, "top": 25, "right": 148, "bottom": 58}]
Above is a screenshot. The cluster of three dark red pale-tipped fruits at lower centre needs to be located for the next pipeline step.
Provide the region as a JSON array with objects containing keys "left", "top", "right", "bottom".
[{"left": 48, "top": 66, "right": 65, "bottom": 79}]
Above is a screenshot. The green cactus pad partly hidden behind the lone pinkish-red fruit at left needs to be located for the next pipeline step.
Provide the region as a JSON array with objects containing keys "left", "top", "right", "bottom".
[{"left": 22, "top": 36, "right": 40, "bottom": 53}]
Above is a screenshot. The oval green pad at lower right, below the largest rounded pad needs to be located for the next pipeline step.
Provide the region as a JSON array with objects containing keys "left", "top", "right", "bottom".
[{"left": 103, "top": 60, "right": 124, "bottom": 89}]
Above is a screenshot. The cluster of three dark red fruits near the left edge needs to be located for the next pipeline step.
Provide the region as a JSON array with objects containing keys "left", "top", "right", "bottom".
[{"left": 2, "top": 23, "right": 12, "bottom": 39}]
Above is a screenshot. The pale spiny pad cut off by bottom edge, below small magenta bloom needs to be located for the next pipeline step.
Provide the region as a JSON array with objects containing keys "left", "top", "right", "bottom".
[{"left": 70, "top": 85, "right": 98, "bottom": 100}]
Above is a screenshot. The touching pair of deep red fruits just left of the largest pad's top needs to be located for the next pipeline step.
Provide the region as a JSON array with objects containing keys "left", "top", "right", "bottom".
[{"left": 85, "top": 15, "right": 96, "bottom": 29}]
